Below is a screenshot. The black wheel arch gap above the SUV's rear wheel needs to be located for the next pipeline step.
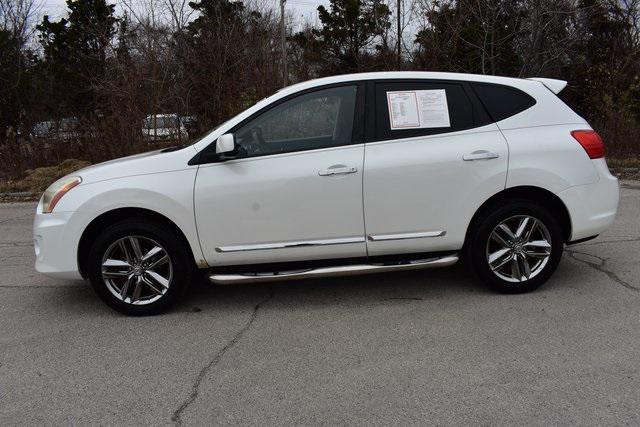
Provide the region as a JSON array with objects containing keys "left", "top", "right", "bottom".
[{"left": 465, "top": 185, "right": 572, "bottom": 245}]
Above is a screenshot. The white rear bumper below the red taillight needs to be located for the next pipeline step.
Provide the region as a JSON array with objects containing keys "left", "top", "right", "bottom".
[{"left": 558, "top": 159, "right": 620, "bottom": 241}]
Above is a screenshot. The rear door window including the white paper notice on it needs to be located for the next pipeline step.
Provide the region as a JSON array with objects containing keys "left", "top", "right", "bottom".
[{"left": 375, "top": 81, "right": 490, "bottom": 140}]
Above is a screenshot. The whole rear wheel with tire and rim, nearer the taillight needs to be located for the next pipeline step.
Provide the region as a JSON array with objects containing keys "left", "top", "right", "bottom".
[{"left": 465, "top": 200, "right": 564, "bottom": 293}]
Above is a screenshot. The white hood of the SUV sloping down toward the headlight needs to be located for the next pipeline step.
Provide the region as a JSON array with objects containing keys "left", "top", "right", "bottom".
[{"left": 70, "top": 146, "right": 197, "bottom": 185}]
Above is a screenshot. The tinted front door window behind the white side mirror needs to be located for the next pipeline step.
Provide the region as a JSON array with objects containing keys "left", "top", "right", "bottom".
[{"left": 234, "top": 86, "right": 357, "bottom": 157}]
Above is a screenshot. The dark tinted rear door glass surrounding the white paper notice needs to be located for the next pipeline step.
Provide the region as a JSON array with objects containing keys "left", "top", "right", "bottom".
[{"left": 375, "top": 81, "right": 488, "bottom": 140}]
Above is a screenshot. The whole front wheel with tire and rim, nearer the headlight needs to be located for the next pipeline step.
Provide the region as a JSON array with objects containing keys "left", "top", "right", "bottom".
[{"left": 88, "top": 220, "right": 192, "bottom": 315}]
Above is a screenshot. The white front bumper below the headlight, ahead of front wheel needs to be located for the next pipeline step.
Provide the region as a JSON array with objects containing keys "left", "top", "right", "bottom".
[{"left": 33, "top": 200, "right": 82, "bottom": 280}]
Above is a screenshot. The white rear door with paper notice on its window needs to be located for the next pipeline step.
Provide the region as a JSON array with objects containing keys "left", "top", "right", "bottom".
[{"left": 364, "top": 80, "right": 508, "bottom": 256}]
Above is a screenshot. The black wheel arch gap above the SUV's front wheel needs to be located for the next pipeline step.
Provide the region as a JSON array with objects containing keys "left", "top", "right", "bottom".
[{"left": 77, "top": 207, "right": 196, "bottom": 278}]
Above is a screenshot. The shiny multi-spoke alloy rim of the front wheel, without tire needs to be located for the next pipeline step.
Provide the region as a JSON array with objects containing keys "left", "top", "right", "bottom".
[{"left": 102, "top": 236, "right": 173, "bottom": 305}]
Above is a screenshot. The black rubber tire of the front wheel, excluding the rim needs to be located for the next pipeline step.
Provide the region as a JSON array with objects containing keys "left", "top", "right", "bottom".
[{"left": 87, "top": 218, "right": 194, "bottom": 316}]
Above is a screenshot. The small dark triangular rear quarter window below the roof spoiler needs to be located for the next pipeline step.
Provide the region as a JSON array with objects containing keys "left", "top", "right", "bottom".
[{"left": 471, "top": 83, "right": 536, "bottom": 122}]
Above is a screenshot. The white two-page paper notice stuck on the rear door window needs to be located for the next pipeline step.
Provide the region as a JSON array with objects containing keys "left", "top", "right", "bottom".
[{"left": 387, "top": 89, "right": 451, "bottom": 130}]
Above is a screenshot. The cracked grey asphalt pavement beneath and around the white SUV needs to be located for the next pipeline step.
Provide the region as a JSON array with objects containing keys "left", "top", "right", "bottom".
[{"left": 0, "top": 182, "right": 640, "bottom": 425}]
